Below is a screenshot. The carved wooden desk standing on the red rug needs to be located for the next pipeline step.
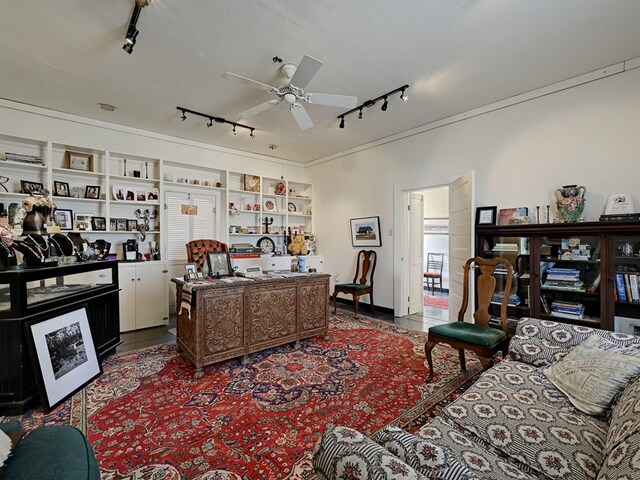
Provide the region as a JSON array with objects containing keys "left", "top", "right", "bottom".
[{"left": 173, "top": 273, "right": 330, "bottom": 378}]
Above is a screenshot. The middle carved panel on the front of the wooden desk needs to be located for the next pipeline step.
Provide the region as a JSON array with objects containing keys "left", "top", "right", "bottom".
[{"left": 245, "top": 283, "right": 296, "bottom": 345}]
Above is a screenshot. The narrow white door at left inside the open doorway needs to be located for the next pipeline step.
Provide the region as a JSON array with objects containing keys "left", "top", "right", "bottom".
[{"left": 408, "top": 192, "right": 424, "bottom": 315}]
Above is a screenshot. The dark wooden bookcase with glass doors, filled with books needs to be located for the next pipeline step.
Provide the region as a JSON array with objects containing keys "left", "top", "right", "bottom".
[{"left": 475, "top": 222, "right": 640, "bottom": 333}]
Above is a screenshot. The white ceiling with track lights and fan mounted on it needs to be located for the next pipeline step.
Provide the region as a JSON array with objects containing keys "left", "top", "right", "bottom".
[{"left": 0, "top": 0, "right": 640, "bottom": 163}]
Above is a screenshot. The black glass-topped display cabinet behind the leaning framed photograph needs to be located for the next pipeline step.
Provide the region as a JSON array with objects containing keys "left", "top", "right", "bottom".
[{"left": 0, "top": 260, "right": 120, "bottom": 415}]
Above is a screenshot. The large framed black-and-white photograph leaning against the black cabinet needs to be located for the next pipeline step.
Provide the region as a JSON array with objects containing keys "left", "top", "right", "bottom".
[{"left": 25, "top": 307, "right": 102, "bottom": 412}]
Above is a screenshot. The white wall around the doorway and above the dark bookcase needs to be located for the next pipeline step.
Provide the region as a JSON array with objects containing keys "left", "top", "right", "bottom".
[{"left": 309, "top": 63, "right": 640, "bottom": 308}]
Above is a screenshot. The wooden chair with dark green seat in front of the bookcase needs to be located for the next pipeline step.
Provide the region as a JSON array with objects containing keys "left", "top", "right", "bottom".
[{"left": 424, "top": 257, "right": 513, "bottom": 383}]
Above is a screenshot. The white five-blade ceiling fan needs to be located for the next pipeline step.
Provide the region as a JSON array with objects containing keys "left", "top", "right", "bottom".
[{"left": 222, "top": 55, "right": 358, "bottom": 130}]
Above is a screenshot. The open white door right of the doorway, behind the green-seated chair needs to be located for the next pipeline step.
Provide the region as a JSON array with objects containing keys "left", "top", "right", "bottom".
[{"left": 449, "top": 172, "right": 475, "bottom": 322}]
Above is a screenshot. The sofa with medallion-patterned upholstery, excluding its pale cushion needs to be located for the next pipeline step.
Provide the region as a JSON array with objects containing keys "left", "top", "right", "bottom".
[{"left": 313, "top": 318, "right": 640, "bottom": 480}]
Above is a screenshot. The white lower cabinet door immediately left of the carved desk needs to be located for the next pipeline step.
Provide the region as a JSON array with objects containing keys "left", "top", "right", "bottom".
[{"left": 135, "top": 262, "right": 169, "bottom": 329}]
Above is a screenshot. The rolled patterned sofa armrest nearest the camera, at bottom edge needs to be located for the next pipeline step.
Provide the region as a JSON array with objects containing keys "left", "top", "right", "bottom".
[{"left": 313, "top": 427, "right": 427, "bottom": 480}]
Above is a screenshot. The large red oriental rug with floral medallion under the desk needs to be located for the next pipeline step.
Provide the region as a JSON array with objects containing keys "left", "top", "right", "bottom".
[{"left": 16, "top": 312, "right": 480, "bottom": 480}]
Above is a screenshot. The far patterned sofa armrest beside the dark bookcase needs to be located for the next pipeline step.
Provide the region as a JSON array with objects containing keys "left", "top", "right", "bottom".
[{"left": 509, "top": 317, "right": 640, "bottom": 367}]
